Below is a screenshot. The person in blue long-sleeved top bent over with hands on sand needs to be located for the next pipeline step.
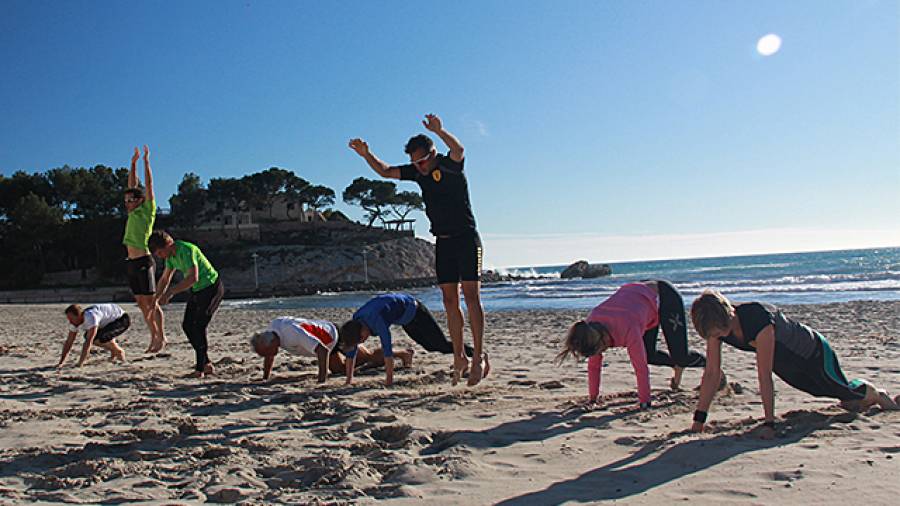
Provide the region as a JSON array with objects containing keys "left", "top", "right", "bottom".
[{"left": 338, "top": 293, "right": 473, "bottom": 386}]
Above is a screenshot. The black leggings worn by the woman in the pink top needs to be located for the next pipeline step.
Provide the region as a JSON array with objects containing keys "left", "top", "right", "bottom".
[{"left": 644, "top": 280, "right": 706, "bottom": 367}]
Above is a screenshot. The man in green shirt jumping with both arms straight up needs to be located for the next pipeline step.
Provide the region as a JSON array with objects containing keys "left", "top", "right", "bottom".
[{"left": 122, "top": 146, "right": 166, "bottom": 353}]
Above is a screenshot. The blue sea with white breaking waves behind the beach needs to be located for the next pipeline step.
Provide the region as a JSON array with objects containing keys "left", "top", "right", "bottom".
[{"left": 227, "top": 248, "right": 900, "bottom": 311}]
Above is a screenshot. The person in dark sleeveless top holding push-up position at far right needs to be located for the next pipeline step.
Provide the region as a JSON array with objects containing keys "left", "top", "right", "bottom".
[{"left": 691, "top": 290, "right": 900, "bottom": 439}]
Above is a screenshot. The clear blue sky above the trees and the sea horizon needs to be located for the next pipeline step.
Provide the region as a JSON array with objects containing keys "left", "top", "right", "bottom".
[{"left": 0, "top": 0, "right": 900, "bottom": 266}]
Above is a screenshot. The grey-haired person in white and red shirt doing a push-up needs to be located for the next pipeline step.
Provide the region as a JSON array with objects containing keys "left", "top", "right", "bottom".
[{"left": 250, "top": 316, "right": 413, "bottom": 383}]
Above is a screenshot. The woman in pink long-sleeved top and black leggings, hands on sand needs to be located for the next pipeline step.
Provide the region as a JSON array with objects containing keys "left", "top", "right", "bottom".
[{"left": 557, "top": 281, "right": 706, "bottom": 409}]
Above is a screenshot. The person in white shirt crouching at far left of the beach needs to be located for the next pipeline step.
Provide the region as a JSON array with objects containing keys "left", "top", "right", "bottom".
[{"left": 56, "top": 304, "right": 131, "bottom": 368}]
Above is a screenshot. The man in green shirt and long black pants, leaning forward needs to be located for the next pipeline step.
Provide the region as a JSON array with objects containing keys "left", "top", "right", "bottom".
[{"left": 147, "top": 230, "right": 225, "bottom": 378}]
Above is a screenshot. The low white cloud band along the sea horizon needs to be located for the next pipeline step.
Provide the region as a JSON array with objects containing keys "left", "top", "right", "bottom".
[{"left": 482, "top": 228, "right": 900, "bottom": 268}]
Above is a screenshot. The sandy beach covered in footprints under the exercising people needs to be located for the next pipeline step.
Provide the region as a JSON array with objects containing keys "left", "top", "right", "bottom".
[{"left": 0, "top": 302, "right": 900, "bottom": 505}]
